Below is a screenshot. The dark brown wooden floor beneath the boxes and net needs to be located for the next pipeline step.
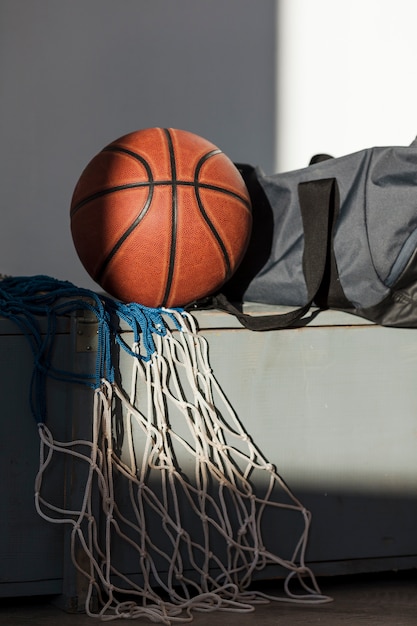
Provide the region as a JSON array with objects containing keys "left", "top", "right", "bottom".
[{"left": 0, "top": 571, "right": 417, "bottom": 626}]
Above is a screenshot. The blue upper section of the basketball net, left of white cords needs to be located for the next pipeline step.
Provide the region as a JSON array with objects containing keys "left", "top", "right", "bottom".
[{"left": 0, "top": 275, "right": 181, "bottom": 422}]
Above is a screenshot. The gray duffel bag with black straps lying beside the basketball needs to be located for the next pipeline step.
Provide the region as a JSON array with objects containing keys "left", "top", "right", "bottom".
[{"left": 210, "top": 140, "right": 417, "bottom": 330}]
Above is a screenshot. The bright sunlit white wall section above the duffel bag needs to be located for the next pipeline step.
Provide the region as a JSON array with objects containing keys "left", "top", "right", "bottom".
[{"left": 276, "top": 0, "right": 417, "bottom": 171}]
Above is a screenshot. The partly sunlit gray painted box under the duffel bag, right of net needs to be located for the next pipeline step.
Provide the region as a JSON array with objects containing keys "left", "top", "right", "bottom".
[{"left": 191, "top": 307, "right": 417, "bottom": 574}]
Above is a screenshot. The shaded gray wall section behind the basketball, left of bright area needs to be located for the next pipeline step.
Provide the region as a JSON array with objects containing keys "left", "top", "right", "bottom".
[{"left": 0, "top": 0, "right": 276, "bottom": 287}]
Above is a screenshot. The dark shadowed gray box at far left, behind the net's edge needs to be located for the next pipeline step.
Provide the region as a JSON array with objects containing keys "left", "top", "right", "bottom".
[{"left": 0, "top": 318, "right": 71, "bottom": 597}]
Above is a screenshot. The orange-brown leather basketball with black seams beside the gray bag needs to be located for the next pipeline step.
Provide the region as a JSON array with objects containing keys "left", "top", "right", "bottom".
[{"left": 70, "top": 128, "right": 252, "bottom": 307}]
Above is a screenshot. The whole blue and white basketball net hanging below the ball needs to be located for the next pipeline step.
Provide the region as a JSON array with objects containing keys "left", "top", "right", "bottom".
[{"left": 0, "top": 277, "right": 329, "bottom": 624}]
